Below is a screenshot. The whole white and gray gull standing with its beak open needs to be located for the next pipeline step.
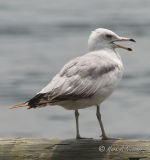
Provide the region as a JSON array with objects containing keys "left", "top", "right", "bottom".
[{"left": 10, "top": 28, "right": 136, "bottom": 140}]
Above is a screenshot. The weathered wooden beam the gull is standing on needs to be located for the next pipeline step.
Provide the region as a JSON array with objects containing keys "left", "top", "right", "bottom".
[{"left": 0, "top": 138, "right": 150, "bottom": 160}]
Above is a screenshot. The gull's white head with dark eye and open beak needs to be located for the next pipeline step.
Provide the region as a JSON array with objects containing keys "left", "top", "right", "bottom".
[{"left": 88, "top": 28, "right": 136, "bottom": 51}]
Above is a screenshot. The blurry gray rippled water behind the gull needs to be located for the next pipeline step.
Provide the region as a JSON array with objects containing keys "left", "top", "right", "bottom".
[{"left": 0, "top": 0, "right": 150, "bottom": 139}]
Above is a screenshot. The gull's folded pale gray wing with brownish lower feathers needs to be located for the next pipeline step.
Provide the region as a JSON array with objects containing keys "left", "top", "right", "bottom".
[{"left": 40, "top": 54, "right": 117, "bottom": 103}]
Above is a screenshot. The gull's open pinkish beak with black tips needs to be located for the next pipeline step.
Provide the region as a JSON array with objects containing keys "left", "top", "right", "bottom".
[{"left": 112, "top": 37, "right": 136, "bottom": 51}]
